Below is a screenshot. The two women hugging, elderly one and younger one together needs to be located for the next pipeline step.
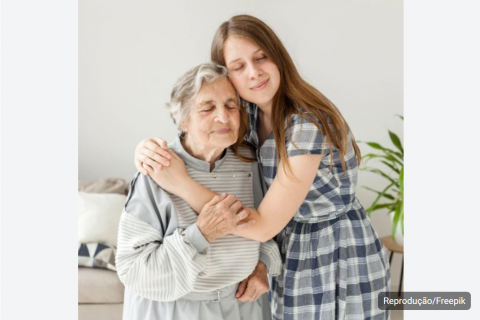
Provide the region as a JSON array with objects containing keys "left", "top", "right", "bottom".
[{"left": 116, "top": 15, "right": 390, "bottom": 320}]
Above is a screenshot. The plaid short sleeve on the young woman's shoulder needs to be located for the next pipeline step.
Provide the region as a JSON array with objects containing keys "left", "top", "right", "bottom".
[{"left": 286, "top": 114, "right": 329, "bottom": 157}]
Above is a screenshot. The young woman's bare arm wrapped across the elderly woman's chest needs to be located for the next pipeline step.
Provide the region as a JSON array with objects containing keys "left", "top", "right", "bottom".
[{"left": 149, "top": 150, "right": 322, "bottom": 242}]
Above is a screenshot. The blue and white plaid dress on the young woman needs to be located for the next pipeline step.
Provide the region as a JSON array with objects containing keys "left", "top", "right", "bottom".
[{"left": 246, "top": 104, "right": 390, "bottom": 320}]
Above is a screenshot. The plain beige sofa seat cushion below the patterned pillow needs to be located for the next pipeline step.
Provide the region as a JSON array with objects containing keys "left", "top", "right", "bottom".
[{"left": 78, "top": 267, "right": 125, "bottom": 303}]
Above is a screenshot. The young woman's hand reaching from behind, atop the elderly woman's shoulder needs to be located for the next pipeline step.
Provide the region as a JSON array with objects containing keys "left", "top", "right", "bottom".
[{"left": 135, "top": 138, "right": 171, "bottom": 175}]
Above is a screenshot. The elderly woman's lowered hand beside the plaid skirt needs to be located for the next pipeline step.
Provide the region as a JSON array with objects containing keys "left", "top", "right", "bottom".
[{"left": 235, "top": 261, "right": 270, "bottom": 302}]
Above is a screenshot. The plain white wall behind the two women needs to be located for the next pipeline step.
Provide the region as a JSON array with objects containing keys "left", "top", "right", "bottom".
[{"left": 78, "top": 0, "right": 403, "bottom": 284}]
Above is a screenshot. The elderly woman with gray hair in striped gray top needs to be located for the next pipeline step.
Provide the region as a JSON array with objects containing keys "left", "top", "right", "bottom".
[{"left": 116, "top": 63, "right": 281, "bottom": 320}]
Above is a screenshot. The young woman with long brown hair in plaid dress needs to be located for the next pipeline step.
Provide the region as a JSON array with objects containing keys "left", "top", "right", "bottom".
[{"left": 135, "top": 15, "right": 390, "bottom": 320}]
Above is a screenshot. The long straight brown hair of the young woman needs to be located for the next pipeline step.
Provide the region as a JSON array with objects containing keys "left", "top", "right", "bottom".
[{"left": 211, "top": 15, "right": 361, "bottom": 172}]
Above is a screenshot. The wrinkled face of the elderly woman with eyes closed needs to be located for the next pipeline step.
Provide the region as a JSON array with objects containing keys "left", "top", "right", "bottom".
[{"left": 183, "top": 78, "right": 240, "bottom": 148}]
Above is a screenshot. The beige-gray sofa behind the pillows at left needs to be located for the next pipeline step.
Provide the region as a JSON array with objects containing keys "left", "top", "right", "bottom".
[{"left": 78, "top": 178, "right": 129, "bottom": 320}]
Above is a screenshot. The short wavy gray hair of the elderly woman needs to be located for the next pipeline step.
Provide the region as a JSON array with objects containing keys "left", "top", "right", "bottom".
[{"left": 167, "top": 62, "right": 240, "bottom": 130}]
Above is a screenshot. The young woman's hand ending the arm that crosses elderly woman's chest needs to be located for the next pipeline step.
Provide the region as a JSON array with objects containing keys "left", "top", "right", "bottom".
[{"left": 143, "top": 149, "right": 190, "bottom": 194}]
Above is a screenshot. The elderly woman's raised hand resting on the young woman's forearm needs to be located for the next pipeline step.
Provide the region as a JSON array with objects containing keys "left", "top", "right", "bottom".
[{"left": 196, "top": 192, "right": 255, "bottom": 243}]
